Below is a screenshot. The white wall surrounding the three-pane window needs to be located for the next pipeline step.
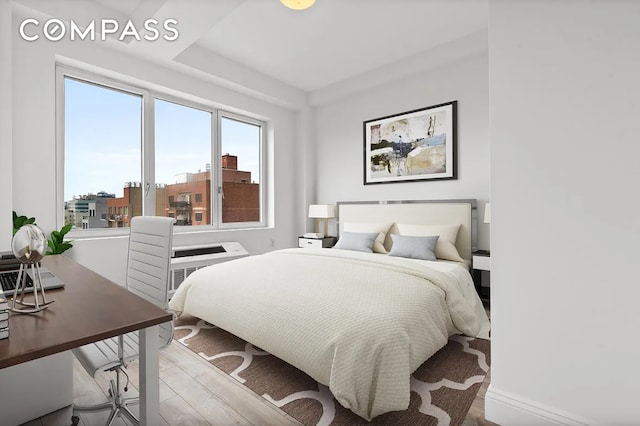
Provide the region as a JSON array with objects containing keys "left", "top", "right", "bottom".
[{"left": 7, "top": 9, "right": 304, "bottom": 281}]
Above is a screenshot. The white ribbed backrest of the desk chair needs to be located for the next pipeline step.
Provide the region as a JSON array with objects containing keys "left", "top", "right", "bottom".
[{"left": 127, "top": 216, "right": 174, "bottom": 347}]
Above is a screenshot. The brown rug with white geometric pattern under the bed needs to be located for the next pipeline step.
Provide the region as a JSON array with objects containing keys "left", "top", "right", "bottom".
[{"left": 174, "top": 314, "right": 490, "bottom": 426}]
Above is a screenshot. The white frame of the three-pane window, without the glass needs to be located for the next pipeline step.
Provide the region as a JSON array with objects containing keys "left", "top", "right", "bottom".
[{"left": 55, "top": 63, "right": 268, "bottom": 238}]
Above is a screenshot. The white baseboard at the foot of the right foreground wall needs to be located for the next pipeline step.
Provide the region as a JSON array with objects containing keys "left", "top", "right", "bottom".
[{"left": 484, "top": 384, "right": 593, "bottom": 426}]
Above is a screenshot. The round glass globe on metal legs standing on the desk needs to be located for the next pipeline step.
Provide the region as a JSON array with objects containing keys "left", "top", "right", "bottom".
[{"left": 9, "top": 225, "right": 55, "bottom": 314}]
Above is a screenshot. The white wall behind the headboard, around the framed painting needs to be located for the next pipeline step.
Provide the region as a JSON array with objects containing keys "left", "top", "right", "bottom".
[{"left": 316, "top": 52, "right": 490, "bottom": 248}]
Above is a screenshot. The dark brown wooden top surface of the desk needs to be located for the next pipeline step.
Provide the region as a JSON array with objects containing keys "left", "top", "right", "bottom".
[{"left": 0, "top": 255, "right": 172, "bottom": 368}]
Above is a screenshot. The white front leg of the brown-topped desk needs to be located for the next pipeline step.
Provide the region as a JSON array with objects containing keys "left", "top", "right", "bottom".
[{"left": 138, "top": 325, "right": 160, "bottom": 426}]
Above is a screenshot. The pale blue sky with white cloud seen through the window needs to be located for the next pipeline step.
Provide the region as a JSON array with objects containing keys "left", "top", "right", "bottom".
[{"left": 64, "top": 78, "right": 260, "bottom": 201}]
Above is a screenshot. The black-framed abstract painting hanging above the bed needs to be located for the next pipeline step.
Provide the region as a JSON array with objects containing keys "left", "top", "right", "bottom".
[{"left": 363, "top": 101, "right": 458, "bottom": 185}]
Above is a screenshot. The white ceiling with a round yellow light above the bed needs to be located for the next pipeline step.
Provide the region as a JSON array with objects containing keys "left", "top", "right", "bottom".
[{"left": 14, "top": 0, "right": 488, "bottom": 92}]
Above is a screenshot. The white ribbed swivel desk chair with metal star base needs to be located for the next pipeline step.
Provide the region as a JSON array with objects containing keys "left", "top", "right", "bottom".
[{"left": 72, "top": 216, "right": 174, "bottom": 425}]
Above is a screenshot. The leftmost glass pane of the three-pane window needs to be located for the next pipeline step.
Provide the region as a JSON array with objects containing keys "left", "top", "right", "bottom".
[{"left": 64, "top": 78, "right": 142, "bottom": 229}]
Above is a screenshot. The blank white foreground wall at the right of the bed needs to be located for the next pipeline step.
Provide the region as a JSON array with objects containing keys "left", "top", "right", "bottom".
[{"left": 486, "top": 0, "right": 640, "bottom": 425}]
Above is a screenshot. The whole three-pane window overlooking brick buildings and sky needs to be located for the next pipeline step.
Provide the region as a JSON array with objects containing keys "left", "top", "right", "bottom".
[{"left": 58, "top": 67, "right": 265, "bottom": 229}]
